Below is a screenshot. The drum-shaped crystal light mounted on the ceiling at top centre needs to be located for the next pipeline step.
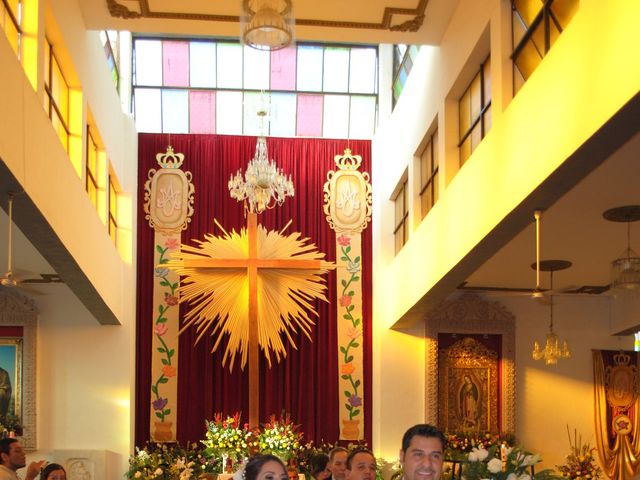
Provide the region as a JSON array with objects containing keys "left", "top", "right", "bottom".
[{"left": 241, "top": 0, "right": 293, "bottom": 51}]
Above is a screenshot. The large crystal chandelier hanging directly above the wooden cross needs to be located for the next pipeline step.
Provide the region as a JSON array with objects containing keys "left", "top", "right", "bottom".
[{"left": 229, "top": 109, "right": 294, "bottom": 213}]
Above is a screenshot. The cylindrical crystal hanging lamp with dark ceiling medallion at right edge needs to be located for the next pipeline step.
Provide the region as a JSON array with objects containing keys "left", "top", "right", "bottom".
[{"left": 602, "top": 205, "right": 640, "bottom": 293}]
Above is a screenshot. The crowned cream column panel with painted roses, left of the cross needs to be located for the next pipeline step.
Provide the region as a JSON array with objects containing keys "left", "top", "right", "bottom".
[{"left": 144, "top": 146, "right": 194, "bottom": 442}]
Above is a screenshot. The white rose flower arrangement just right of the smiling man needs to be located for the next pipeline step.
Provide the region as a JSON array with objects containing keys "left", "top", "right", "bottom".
[{"left": 463, "top": 445, "right": 557, "bottom": 480}]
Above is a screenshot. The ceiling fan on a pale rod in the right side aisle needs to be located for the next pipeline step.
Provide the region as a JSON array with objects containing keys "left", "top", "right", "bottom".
[{"left": 458, "top": 210, "right": 609, "bottom": 303}]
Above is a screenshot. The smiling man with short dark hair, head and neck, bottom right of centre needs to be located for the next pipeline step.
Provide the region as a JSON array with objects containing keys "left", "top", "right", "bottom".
[{"left": 400, "top": 423, "right": 447, "bottom": 480}]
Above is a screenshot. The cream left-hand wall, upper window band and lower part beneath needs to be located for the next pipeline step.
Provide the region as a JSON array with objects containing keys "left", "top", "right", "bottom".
[{"left": 0, "top": 0, "right": 137, "bottom": 468}]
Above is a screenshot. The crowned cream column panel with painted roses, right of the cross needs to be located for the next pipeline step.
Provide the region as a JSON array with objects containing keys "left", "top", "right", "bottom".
[{"left": 324, "top": 148, "right": 372, "bottom": 440}]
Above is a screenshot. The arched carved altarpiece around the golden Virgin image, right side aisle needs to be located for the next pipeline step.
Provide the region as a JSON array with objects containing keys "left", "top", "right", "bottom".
[{"left": 425, "top": 294, "right": 515, "bottom": 433}]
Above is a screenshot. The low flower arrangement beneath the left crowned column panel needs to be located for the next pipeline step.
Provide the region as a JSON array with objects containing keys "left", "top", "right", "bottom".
[{"left": 126, "top": 444, "right": 218, "bottom": 480}]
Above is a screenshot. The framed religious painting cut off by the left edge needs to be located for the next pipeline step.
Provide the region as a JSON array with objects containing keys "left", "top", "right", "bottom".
[{"left": 0, "top": 337, "right": 22, "bottom": 426}]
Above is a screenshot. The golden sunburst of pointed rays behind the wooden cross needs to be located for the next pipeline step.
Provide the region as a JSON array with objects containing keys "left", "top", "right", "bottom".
[{"left": 163, "top": 222, "right": 335, "bottom": 369}]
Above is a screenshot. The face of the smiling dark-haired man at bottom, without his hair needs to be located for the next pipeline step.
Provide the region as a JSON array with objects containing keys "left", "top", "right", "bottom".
[{"left": 400, "top": 435, "right": 444, "bottom": 480}]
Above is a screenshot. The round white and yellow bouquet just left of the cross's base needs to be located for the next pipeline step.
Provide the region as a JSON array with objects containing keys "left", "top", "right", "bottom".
[{"left": 202, "top": 413, "right": 256, "bottom": 462}]
